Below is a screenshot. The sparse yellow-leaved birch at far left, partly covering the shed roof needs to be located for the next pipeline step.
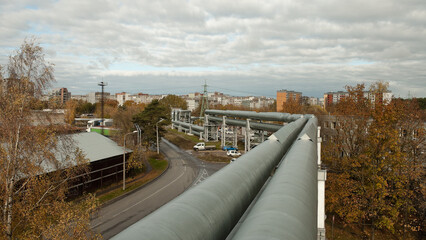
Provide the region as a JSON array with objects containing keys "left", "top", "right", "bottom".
[{"left": 0, "top": 40, "right": 96, "bottom": 239}]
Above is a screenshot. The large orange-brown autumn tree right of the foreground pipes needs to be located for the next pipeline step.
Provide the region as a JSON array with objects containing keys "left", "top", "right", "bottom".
[{"left": 322, "top": 83, "right": 424, "bottom": 238}]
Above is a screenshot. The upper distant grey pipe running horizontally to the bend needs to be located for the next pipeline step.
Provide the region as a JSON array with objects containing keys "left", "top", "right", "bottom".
[{"left": 206, "top": 109, "right": 302, "bottom": 122}]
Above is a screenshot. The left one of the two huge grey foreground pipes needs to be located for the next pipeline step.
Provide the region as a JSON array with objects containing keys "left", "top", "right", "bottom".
[{"left": 113, "top": 118, "right": 307, "bottom": 240}]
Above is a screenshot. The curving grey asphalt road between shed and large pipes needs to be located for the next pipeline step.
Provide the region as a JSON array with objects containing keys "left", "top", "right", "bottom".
[{"left": 91, "top": 139, "right": 226, "bottom": 239}]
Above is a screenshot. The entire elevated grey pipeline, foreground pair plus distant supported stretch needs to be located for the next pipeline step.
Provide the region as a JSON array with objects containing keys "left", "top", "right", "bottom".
[{"left": 113, "top": 110, "right": 325, "bottom": 240}]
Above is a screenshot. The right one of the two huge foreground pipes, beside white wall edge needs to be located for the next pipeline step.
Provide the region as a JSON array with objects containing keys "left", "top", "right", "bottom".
[{"left": 232, "top": 118, "right": 318, "bottom": 240}]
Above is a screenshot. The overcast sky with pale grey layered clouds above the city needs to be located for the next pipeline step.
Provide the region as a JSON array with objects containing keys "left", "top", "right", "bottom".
[{"left": 0, "top": 0, "right": 426, "bottom": 97}]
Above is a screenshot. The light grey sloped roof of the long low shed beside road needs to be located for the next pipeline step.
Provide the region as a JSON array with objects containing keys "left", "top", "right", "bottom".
[{"left": 71, "top": 132, "right": 132, "bottom": 162}]
